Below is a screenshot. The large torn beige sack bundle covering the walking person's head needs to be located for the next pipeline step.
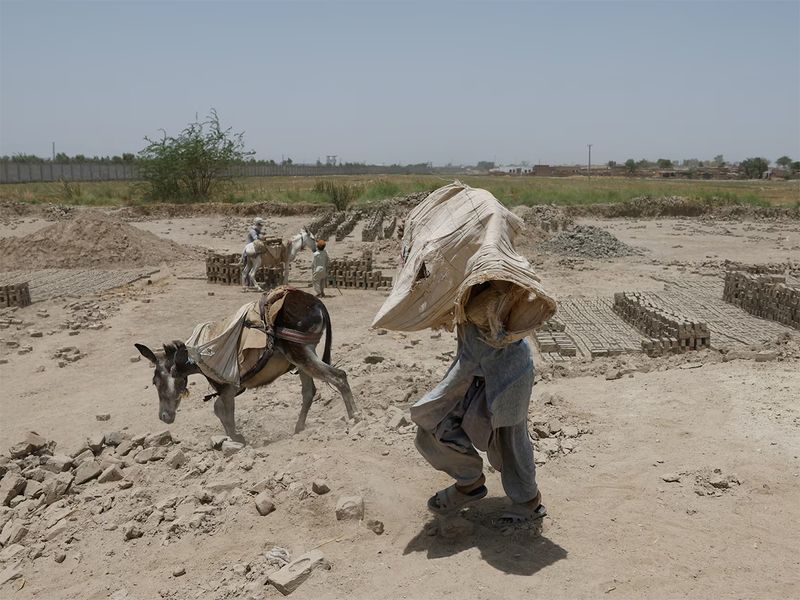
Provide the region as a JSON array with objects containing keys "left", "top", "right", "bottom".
[{"left": 372, "top": 181, "right": 556, "bottom": 346}]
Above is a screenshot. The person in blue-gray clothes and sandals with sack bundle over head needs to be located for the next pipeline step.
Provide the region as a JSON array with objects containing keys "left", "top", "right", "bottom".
[{"left": 373, "top": 182, "right": 555, "bottom": 524}]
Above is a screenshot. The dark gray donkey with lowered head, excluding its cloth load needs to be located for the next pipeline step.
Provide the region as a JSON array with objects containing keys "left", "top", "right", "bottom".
[{"left": 135, "top": 290, "right": 359, "bottom": 442}]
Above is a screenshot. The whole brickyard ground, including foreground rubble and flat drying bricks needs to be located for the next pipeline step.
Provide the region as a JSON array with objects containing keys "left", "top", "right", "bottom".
[{"left": 0, "top": 207, "right": 800, "bottom": 600}]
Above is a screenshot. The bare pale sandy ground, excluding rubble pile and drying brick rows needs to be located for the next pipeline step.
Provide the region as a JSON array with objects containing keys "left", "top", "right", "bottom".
[{"left": 0, "top": 212, "right": 800, "bottom": 600}]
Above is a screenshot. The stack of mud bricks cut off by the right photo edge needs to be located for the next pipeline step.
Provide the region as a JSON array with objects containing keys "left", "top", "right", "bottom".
[{"left": 722, "top": 271, "right": 800, "bottom": 329}]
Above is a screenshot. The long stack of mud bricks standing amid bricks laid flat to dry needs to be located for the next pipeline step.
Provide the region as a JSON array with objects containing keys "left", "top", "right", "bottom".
[{"left": 614, "top": 292, "right": 711, "bottom": 356}]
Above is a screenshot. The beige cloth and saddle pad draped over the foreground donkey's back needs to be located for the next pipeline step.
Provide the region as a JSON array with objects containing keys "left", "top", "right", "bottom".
[{"left": 186, "top": 286, "right": 322, "bottom": 385}]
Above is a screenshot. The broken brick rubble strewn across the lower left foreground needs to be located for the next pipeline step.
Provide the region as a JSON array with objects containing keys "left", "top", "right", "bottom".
[{"left": 0, "top": 426, "right": 384, "bottom": 597}]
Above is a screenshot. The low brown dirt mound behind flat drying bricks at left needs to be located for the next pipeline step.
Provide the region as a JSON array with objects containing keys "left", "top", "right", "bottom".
[{"left": 0, "top": 214, "right": 200, "bottom": 270}]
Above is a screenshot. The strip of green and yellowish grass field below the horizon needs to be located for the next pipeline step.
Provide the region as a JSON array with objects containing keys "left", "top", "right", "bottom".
[{"left": 0, "top": 175, "right": 800, "bottom": 208}]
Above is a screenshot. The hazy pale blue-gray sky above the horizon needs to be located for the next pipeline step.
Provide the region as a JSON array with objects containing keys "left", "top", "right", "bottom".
[{"left": 0, "top": 0, "right": 800, "bottom": 164}]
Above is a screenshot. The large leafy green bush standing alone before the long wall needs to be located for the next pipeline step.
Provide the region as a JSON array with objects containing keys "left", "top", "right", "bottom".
[{"left": 139, "top": 108, "right": 253, "bottom": 202}]
